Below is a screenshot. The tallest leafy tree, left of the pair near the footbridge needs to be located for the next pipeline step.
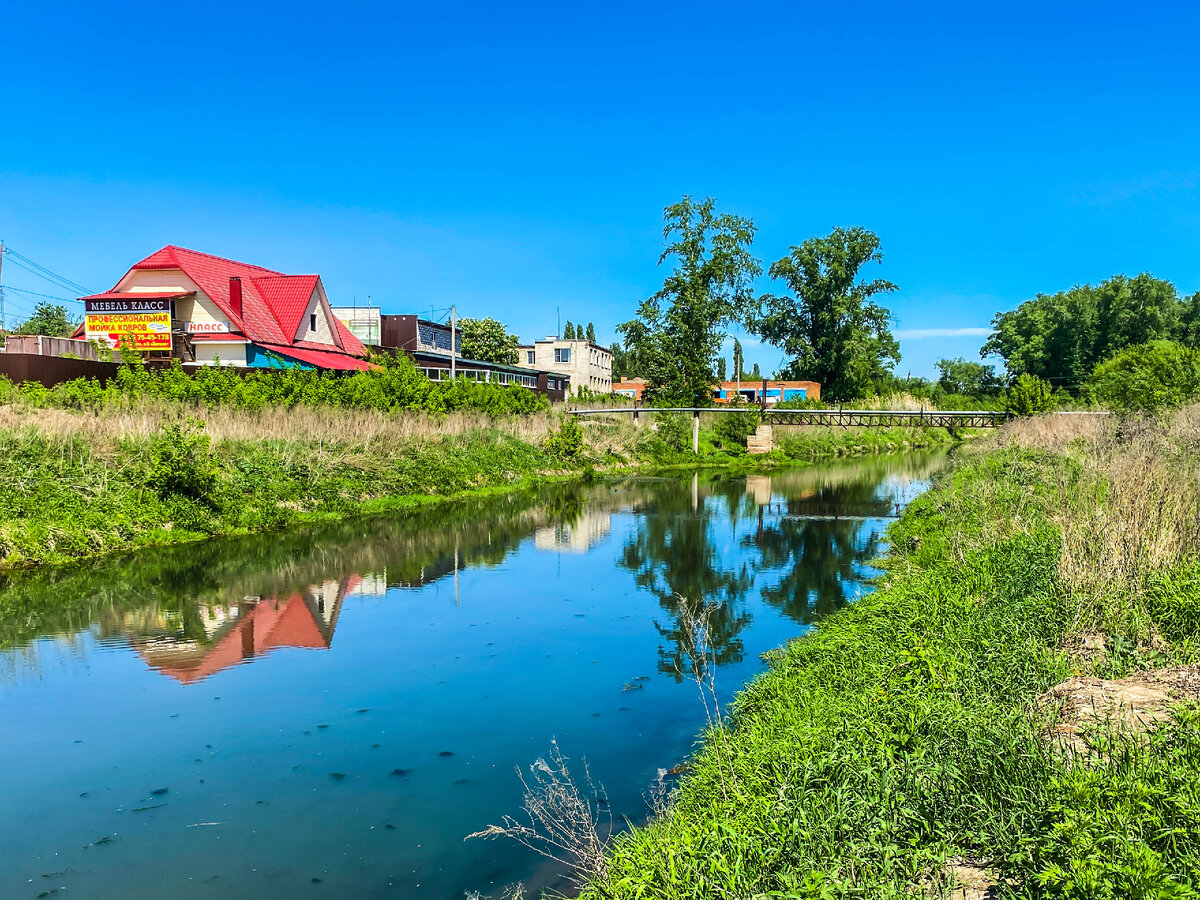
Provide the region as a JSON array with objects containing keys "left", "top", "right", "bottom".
[{"left": 618, "top": 197, "right": 762, "bottom": 406}]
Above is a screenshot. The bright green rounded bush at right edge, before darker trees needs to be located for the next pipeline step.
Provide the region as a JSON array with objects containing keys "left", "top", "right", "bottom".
[{"left": 1086, "top": 341, "right": 1200, "bottom": 412}]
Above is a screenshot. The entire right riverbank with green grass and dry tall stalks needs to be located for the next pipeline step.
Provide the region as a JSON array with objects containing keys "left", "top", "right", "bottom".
[{"left": 587, "top": 409, "right": 1200, "bottom": 900}]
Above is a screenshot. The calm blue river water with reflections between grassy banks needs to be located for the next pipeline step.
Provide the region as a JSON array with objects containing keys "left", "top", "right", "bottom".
[{"left": 0, "top": 456, "right": 940, "bottom": 900}]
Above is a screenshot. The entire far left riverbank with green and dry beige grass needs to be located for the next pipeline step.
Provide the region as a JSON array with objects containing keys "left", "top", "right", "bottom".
[{"left": 0, "top": 396, "right": 952, "bottom": 570}]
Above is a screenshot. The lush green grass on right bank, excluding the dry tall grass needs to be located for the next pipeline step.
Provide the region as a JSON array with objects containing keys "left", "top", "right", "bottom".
[{"left": 587, "top": 450, "right": 1200, "bottom": 900}]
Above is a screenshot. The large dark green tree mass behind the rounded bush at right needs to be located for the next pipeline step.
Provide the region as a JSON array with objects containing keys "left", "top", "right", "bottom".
[{"left": 979, "top": 272, "right": 1180, "bottom": 394}]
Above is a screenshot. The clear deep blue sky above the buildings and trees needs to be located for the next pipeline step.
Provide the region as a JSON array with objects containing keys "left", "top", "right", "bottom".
[{"left": 0, "top": 0, "right": 1200, "bottom": 374}]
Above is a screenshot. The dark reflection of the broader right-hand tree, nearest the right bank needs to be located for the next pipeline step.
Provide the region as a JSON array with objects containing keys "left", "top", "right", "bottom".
[{"left": 742, "top": 479, "right": 892, "bottom": 624}]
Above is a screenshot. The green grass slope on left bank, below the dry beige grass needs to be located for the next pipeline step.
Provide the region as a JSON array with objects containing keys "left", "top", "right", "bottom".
[{"left": 0, "top": 428, "right": 563, "bottom": 568}]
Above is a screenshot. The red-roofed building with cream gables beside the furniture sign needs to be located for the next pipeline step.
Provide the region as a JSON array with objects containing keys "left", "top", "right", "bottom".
[{"left": 79, "top": 246, "right": 371, "bottom": 370}]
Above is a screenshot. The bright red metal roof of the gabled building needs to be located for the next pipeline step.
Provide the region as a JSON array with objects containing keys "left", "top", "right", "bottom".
[{"left": 92, "top": 245, "right": 370, "bottom": 368}]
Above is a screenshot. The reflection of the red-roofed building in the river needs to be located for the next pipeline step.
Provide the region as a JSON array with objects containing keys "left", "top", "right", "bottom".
[{"left": 134, "top": 575, "right": 359, "bottom": 684}]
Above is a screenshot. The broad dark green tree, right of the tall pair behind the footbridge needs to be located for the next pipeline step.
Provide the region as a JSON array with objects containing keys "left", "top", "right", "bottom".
[{"left": 755, "top": 228, "right": 900, "bottom": 401}]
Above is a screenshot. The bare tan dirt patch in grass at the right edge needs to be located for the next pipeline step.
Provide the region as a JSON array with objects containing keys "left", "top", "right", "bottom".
[{"left": 1037, "top": 665, "right": 1200, "bottom": 754}]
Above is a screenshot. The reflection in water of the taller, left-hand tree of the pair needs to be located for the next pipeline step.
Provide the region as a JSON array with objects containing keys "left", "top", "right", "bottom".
[{"left": 620, "top": 481, "right": 752, "bottom": 680}]
